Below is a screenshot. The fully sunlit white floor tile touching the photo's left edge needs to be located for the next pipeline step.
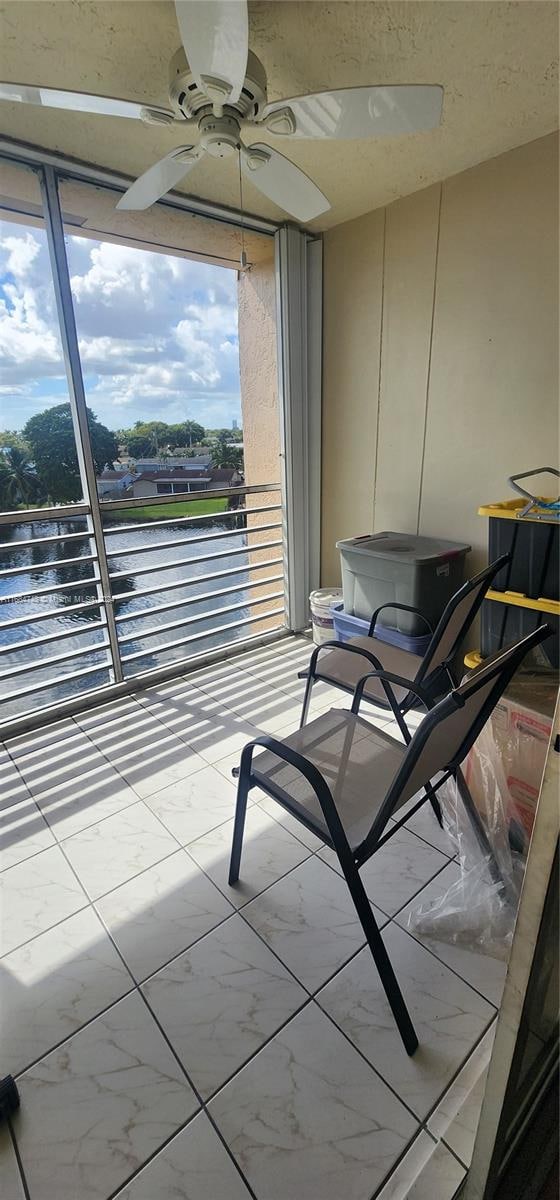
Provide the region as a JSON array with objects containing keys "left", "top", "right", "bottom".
[{"left": 0, "top": 846, "right": 88, "bottom": 956}]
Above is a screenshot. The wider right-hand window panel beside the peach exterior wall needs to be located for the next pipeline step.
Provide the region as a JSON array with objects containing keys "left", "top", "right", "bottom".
[{"left": 60, "top": 179, "right": 283, "bottom": 677}]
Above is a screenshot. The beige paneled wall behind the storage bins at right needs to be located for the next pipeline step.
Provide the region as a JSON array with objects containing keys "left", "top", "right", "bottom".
[{"left": 321, "top": 134, "right": 559, "bottom": 584}]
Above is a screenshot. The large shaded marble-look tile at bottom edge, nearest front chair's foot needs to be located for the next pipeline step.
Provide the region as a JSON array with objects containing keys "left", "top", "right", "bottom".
[{"left": 210, "top": 1002, "right": 417, "bottom": 1200}]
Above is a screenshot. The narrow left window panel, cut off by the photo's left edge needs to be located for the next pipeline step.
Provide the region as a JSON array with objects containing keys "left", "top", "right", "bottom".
[{"left": 0, "top": 160, "right": 109, "bottom": 721}]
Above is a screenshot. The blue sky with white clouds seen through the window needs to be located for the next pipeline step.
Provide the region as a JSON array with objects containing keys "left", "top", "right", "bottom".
[{"left": 0, "top": 221, "right": 241, "bottom": 430}]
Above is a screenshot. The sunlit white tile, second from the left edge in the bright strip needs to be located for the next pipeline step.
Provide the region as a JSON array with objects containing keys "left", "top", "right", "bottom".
[{"left": 64, "top": 800, "right": 177, "bottom": 900}]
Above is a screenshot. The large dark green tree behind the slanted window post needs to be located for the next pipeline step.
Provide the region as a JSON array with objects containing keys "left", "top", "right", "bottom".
[{"left": 23, "top": 404, "right": 119, "bottom": 504}]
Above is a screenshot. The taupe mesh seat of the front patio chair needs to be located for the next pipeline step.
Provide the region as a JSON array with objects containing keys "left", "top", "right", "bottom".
[{"left": 252, "top": 705, "right": 407, "bottom": 850}]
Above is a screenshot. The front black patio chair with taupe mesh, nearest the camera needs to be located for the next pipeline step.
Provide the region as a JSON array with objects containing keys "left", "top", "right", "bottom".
[{"left": 229, "top": 625, "right": 550, "bottom": 1055}]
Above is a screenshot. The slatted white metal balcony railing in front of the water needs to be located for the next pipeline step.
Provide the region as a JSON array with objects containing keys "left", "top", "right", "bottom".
[{"left": 0, "top": 484, "right": 285, "bottom": 731}]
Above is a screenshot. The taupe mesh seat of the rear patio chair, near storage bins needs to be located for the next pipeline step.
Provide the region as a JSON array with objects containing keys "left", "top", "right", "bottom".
[{"left": 315, "top": 637, "right": 422, "bottom": 708}]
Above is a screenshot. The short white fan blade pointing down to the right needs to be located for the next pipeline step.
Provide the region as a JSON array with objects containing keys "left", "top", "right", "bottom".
[{"left": 241, "top": 144, "right": 331, "bottom": 221}]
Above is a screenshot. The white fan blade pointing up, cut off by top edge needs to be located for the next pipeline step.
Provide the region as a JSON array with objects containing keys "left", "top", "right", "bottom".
[{"left": 175, "top": 0, "right": 249, "bottom": 104}]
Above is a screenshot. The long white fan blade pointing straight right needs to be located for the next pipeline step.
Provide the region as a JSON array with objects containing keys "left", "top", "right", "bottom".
[{"left": 261, "top": 84, "right": 444, "bottom": 138}]
